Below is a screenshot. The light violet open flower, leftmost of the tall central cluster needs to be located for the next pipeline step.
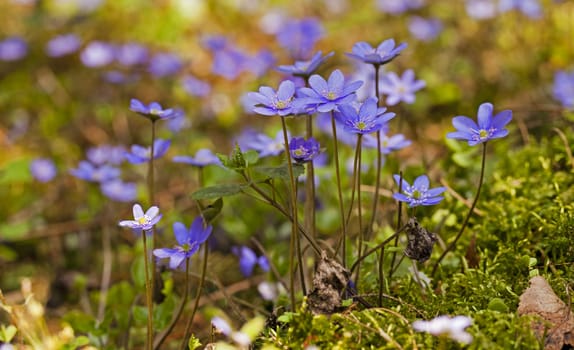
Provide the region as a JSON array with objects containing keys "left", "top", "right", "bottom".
[{"left": 247, "top": 80, "right": 295, "bottom": 116}]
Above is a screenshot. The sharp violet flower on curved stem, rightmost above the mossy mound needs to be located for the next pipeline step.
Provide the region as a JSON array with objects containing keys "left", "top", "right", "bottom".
[{"left": 446, "top": 102, "right": 512, "bottom": 146}]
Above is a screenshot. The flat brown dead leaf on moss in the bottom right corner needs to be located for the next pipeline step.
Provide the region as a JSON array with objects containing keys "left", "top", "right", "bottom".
[{"left": 518, "top": 276, "right": 574, "bottom": 350}]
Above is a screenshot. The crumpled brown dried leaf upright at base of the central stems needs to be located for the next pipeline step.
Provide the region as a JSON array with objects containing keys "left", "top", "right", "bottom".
[{"left": 307, "top": 251, "right": 350, "bottom": 315}]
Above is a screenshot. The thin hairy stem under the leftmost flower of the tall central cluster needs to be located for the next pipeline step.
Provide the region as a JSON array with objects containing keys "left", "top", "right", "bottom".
[{"left": 281, "top": 117, "right": 307, "bottom": 304}]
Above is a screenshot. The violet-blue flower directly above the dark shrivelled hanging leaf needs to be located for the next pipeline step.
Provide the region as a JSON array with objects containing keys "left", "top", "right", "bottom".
[{"left": 393, "top": 175, "right": 446, "bottom": 208}]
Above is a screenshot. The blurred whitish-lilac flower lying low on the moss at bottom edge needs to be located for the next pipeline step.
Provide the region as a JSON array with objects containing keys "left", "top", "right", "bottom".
[{"left": 413, "top": 315, "right": 472, "bottom": 344}]
